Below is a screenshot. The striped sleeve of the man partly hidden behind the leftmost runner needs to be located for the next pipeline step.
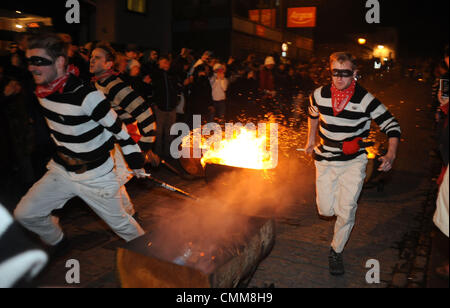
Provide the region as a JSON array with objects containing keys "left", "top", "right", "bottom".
[{"left": 109, "top": 79, "right": 156, "bottom": 151}]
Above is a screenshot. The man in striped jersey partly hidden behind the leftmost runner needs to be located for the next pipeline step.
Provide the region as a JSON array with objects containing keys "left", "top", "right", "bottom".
[{"left": 90, "top": 43, "right": 159, "bottom": 215}]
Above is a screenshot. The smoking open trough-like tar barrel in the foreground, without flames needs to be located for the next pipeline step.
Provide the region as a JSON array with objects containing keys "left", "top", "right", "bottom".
[{"left": 117, "top": 217, "right": 275, "bottom": 288}]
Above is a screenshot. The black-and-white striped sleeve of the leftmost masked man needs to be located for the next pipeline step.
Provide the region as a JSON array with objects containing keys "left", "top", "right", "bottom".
[{"left": 82, "top": 91, "right": 144, "bottom": 169}]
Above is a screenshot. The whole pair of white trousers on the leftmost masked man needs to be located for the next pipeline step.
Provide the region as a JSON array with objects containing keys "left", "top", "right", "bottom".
[{"left": 14, "top": 164, "right": 144, "bottom": 246}]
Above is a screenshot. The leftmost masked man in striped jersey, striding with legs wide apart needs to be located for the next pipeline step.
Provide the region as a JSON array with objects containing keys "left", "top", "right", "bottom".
[{"left": 14, "top": 34, "right": 145, "bottom": 251}]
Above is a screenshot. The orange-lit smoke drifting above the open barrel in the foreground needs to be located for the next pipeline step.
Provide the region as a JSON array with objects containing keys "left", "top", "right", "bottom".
[{"left": 146, "top": 126, "right": 313, "bottom": 269}]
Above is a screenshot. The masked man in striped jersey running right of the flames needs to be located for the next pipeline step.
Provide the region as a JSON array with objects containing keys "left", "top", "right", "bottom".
[{"left": 306, "top": 52, "right": 401, "bottom": 275}]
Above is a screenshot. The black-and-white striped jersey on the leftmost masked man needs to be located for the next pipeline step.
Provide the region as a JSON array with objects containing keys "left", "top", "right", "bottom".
[{"left": 39, "top": 75, "right": 144, "bottom": 179}]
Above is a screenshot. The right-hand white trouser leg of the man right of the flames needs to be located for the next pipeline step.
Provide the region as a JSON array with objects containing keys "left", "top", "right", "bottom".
[{"left": 331, "top": 156, "right": 367, "bottom": 253}]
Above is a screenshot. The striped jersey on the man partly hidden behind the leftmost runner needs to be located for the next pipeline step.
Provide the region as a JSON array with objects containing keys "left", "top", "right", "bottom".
[{"left": 95, "top": 76, "right": 156, "bottom": 151}]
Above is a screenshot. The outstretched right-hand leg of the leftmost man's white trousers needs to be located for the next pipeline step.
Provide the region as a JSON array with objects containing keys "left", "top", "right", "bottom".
[{"left": 76, "top": 172, "right": 144, "bottom": 242}]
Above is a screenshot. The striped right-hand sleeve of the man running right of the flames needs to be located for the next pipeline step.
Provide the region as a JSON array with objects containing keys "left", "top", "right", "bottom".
[{"left": 367, "top": 98, "right": 402, "bottom": 138}]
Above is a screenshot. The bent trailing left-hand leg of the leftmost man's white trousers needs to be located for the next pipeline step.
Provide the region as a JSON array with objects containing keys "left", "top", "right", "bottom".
[{"left": 14, "top": 171, "right": 76, "bottom": 246}]
